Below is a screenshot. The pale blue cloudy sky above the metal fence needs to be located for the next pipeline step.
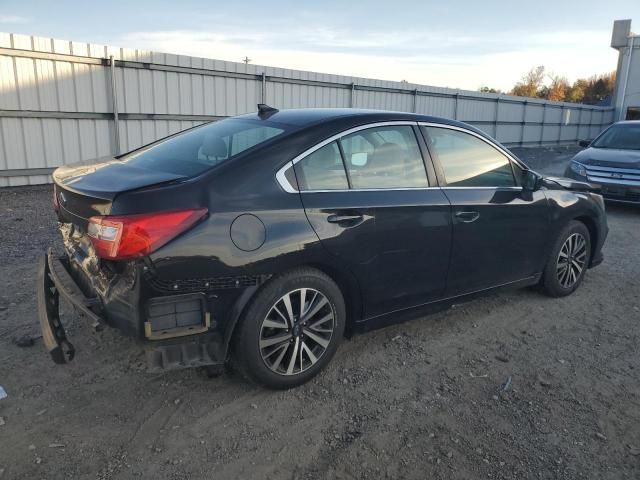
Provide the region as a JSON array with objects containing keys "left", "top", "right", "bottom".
[{"left": 0, "top": 0, "right": 640, "bottom": 91}]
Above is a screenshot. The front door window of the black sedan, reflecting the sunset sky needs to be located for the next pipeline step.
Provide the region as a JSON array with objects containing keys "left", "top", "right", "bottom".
[{"left": 423, "top": 127, "right": 516, "bottom": 187}]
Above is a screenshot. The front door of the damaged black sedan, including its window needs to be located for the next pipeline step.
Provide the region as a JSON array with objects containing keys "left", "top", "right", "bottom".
[{"left": 421, "top": 124, "right": 549, "bottom": 296}]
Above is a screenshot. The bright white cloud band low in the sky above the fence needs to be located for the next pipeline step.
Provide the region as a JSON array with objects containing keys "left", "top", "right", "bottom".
[{"left": 119, "top": 27, "right": 616, "bottom": 90}]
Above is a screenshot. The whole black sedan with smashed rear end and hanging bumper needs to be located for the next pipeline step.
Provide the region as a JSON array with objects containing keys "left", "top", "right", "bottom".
[{"left": 38, "top": 105, "right": 607, "bottom": 388}]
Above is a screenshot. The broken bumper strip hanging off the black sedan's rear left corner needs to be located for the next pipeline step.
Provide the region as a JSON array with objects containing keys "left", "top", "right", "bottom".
[{"left": 37, "top": 249, "right": 103, "bottom": 364}]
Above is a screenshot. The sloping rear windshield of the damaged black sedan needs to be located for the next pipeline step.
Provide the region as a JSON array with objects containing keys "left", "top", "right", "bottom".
[{"left": 120, "top": 118, "right": 285, "bottom": 177}]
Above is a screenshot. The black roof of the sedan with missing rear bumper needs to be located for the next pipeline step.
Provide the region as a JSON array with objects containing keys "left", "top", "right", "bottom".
[{"left": 237, "top": 108, "right": 477, "bottom": 131}]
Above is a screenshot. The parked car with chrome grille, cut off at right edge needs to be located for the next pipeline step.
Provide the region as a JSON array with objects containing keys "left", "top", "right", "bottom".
[{"left": 565, "top": 120, "right": 640, "bottom": 205}]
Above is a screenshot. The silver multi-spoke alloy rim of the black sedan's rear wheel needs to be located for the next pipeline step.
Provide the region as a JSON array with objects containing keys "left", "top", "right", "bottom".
[{"left": 260, "top": 288, "right": 336, "bottom": 375}]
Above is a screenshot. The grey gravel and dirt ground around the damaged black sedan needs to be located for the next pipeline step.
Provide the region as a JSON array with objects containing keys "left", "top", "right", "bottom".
[{"left": 0, "top": 148, "right": 640, "bottom": 480}]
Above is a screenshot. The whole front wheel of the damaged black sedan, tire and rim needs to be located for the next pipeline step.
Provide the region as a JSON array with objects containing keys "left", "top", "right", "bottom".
[{"left": 541, "top": 220, "right": 591, "bottom": 297}]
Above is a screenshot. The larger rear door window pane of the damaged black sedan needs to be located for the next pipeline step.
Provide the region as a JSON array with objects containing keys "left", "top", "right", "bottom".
[{"left": 340, "top": 125, "right": 429, "bottom": 189}]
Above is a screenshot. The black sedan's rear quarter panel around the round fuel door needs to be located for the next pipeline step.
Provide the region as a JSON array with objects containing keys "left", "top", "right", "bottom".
[{"left": 114, "top": 137, "right": 361, "bottom": 346}]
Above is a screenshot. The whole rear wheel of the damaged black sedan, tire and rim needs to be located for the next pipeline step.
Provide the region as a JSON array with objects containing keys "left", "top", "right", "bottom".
[{"left": 232, "top": 268, "right": 346, "bottom": 389}]
